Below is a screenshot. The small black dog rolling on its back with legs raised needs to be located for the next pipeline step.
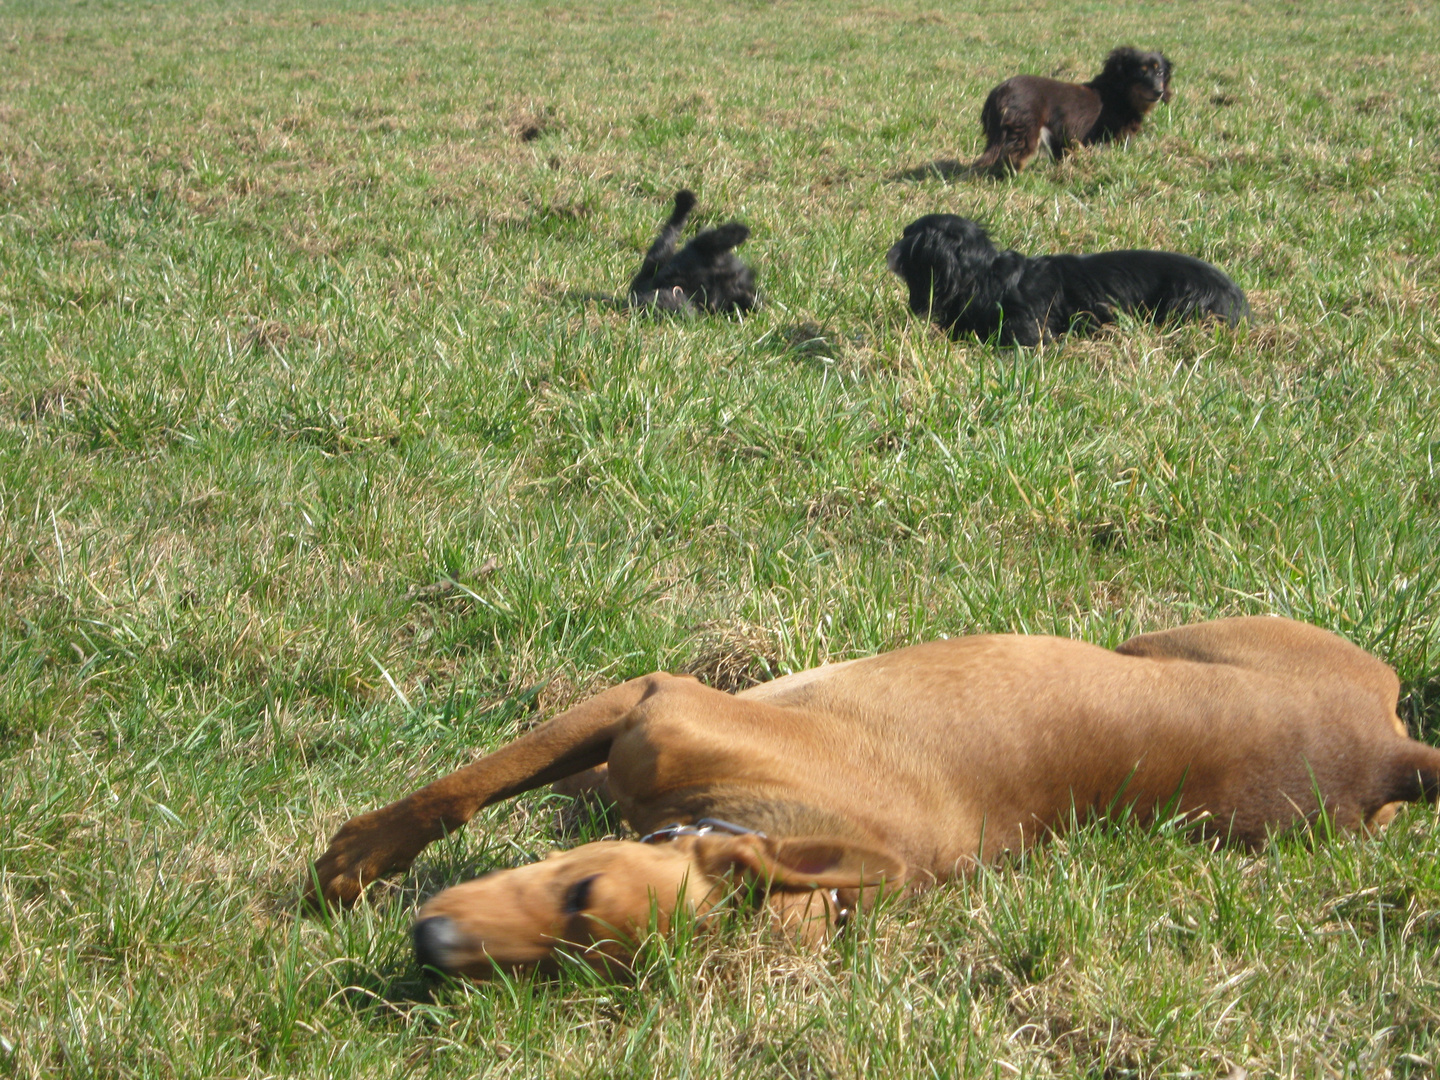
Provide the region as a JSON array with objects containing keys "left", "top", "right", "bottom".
[{"left": 629, "top": 190, "right": 757, "bottom": 312}]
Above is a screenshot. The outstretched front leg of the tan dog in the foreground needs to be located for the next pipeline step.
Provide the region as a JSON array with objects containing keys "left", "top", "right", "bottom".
[{"left": 308, "top": 674, "right": 674, "bottom": 906}]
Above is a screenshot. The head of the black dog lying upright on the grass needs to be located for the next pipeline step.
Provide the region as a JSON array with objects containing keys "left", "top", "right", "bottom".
[{"left": 886, "top": 213, "right": 999, "bottom": 324}]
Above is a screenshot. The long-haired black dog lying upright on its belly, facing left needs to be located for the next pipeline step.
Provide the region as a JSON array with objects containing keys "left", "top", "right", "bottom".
[{"left": 886, "top": 213, "right": 1250, "bottom": 346}]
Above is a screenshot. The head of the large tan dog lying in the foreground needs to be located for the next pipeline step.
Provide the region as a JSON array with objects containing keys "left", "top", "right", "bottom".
[{"left": 415, "top": 834, "right": 906, "bottom": 976}]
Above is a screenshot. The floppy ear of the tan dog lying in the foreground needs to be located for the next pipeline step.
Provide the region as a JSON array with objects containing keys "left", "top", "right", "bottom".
[{"left": 696, "top": 834, "right": 906, "bottom": 888}]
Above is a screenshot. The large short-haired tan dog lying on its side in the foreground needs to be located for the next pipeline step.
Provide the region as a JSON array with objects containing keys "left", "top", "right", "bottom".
[{"left": 314, "top": 618, "right": 1440, "bottom": 975}]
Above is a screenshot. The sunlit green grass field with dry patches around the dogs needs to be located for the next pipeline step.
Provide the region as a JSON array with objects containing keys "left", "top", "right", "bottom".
[{"left": 0, "top": 0, "right": 1440, "bottom": 1080}]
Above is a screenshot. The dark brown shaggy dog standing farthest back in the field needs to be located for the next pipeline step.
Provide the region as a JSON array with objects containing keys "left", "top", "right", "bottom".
[{"left": 971, "top": 48, "right": 1174, "bottom": 176}]
